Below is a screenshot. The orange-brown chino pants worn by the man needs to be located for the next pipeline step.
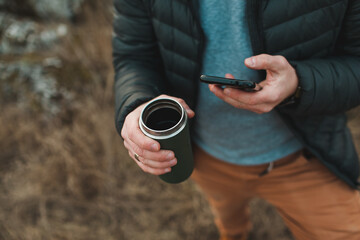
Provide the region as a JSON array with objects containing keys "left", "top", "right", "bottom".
[{"left": 192, "top": 147, "right": 360, "bottom": 240}]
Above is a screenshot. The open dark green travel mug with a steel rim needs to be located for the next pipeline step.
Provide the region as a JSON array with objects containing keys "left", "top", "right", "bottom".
[{"left": 139, "top": 98, "right": 194, "bottom": 183}]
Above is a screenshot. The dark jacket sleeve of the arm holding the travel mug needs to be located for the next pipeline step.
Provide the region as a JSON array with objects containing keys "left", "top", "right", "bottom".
[{"left": 112, "top": 0, "right": 164, "bottom": 133}]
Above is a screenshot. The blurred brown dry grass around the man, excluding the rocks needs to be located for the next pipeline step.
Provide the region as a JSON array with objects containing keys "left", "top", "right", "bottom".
[{"left": 0, "top": 1, "right": 360, "bottom": 240}]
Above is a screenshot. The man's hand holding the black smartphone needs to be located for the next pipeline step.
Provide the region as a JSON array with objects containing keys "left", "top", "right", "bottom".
[{"left": 209, "top": 54, "right": 299, "bottom": 113}]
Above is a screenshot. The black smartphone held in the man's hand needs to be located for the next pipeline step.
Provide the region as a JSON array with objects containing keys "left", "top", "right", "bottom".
[{"left": 200, "top": 75, "right": 262, "bottom": 92}]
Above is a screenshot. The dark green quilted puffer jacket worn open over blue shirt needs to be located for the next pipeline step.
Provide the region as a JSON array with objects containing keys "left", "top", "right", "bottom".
[{"left": 113, "top": 0, "right": 360, "bottom": 187}]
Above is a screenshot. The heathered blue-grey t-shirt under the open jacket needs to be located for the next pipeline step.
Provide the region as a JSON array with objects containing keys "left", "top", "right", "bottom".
[{"left": 193, "top": 0, "right": 302, "bottom": 165}]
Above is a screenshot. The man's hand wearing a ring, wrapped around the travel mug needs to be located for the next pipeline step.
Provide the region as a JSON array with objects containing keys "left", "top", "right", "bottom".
[{"left": 121, "top": 95, "right": 195, "bottom": 175}]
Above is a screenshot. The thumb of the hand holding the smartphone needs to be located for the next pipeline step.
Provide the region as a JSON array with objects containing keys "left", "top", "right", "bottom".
[{"left": 244, "top": 54, "right": 289, "bottom": 73}]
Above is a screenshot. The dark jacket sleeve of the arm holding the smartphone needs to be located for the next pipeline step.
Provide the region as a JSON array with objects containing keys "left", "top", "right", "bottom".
[{"left": 280, "top": 0, "right": 360, "bottom": 115}]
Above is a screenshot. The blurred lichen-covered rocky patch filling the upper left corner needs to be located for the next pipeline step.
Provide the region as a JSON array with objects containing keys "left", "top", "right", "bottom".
[{"left": 0, "top": 0, "right": 85, "bottom": 115}]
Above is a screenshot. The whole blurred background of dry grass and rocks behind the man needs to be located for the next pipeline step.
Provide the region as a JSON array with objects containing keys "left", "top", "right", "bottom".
[{"left": 0, "top": 0, "right": 360, "bottom": 240}]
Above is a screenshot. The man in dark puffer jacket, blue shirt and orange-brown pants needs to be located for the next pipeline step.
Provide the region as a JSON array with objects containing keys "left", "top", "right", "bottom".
[{"left": 113, "top": 0, "right": 360, "bottom": 240}]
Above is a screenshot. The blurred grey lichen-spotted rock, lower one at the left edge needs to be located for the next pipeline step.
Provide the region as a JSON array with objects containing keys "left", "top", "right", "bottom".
[{"left": 0, "top": 61, "right": 72, "bottom": 115}]
